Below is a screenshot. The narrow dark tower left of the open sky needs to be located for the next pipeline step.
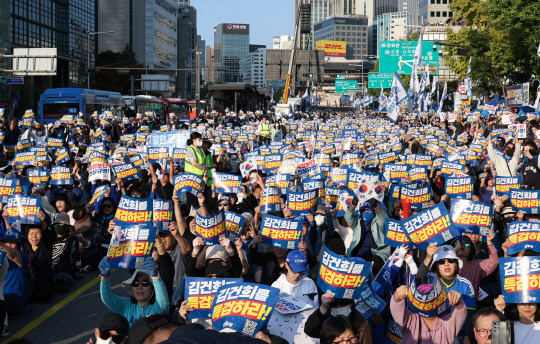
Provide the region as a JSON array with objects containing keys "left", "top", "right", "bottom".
[{"left": 176, "top": 0, "right": 197, "bottom": 99}]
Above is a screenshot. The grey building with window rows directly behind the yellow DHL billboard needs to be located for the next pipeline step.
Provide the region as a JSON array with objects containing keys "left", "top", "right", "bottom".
[{"left": 314, "top": 15, "right": 368, "bottom": 60}]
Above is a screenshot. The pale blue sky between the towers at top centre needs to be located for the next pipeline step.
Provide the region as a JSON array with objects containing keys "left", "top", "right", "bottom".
[{"left": 191, "top": 0, "right": 294, "bottom": 49}]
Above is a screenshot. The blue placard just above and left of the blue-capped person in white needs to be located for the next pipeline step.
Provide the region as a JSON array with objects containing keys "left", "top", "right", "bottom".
[{"left": 261, "top": 214, "right": 302, "bottom": 250}]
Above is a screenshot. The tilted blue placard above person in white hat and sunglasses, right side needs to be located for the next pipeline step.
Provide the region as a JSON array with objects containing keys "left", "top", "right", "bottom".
[{"left": 401, "top": 203, "right": 459, "bottom": 250}]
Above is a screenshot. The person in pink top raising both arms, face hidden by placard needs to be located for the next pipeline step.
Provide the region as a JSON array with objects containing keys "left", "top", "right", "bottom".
[{"left": 390, "top": 284, "right": 467, "bottom": 344}]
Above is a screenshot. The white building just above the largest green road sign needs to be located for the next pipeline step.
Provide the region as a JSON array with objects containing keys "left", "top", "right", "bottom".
[{"left": 377, "top": 12, "right": 418, "bottom": 46}]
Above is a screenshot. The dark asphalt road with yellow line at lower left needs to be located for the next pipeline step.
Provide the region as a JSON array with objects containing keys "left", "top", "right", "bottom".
[{"left": 0, "top": 270, "right": 130, "bottom": 344}]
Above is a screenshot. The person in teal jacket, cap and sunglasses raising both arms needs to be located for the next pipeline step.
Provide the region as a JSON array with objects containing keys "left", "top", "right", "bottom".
[{"left": 99, "top": 256, "right": 169, "bottom": 326}]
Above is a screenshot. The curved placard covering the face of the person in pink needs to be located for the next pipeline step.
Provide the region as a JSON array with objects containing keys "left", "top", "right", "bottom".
[{"left": 407, "top": 277, "right": 450, "bottom": 318}]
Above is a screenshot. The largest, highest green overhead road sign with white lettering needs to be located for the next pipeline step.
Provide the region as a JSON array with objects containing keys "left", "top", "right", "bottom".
[{"left": 379, "top": 41, "right": 439, "bottom": 75}]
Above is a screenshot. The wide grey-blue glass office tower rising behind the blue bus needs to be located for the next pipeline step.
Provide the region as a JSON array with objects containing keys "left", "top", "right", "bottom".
[{"left": 97, "top": 0, "right": 178, "bottom": 84}]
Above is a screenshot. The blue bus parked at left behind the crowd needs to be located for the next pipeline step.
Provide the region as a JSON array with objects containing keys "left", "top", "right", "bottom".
[{"left": 39, "top": 88, "right": 126, "bottom": 123}]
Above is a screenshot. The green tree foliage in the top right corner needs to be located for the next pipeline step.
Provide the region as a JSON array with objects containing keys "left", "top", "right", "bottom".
[{"left": 443, "top": 0, "right": 540, "bottom": 94}]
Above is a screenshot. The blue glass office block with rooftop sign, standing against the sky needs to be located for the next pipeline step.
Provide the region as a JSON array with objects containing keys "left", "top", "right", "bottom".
[{"left": 214, "top": 23, "right": 249, "bottom": 83}]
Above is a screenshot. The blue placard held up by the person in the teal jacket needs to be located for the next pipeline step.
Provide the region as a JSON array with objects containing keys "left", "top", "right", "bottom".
[{"left": 107, "top": 224, "right": 156, "bottom": 269}]
